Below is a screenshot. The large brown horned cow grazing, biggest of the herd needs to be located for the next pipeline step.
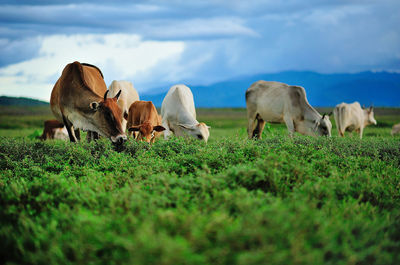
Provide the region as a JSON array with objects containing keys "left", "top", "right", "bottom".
[{"left": 50, "top": 62, "right": 127, "bottom": 146}]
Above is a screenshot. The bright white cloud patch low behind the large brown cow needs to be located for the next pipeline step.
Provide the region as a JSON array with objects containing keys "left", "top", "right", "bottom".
[{"left": 0, "top": 34, "right": 185, "bottom": 100}]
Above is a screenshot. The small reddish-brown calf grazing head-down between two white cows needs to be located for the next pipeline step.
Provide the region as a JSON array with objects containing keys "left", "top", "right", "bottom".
[{"left": 127, "top": 100, "right": 165, "bottom": 144}]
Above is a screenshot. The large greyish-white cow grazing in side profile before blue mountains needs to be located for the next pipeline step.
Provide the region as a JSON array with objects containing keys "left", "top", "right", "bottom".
[{"left": 246, "top": 80, "right": 332, "bottom": 139}]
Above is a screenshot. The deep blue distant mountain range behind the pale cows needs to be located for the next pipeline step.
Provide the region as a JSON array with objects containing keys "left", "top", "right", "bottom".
[{"left": 140, "top": 71, "right": 400, "bottom": 107}]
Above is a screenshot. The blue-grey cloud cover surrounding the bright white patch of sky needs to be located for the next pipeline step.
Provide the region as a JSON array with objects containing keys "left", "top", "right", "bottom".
[{"left": 0, "top": 0, "right": 400, "bottom": 83}]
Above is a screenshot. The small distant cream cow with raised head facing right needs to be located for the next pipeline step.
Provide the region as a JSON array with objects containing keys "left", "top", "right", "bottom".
[{"left": 333, "top": 101, "right": 376, "bottom": 139}]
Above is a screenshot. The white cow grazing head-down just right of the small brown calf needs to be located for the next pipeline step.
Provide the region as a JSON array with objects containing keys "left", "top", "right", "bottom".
[{"left": 161, "top": 85, "right": 210, "bottom": 142}]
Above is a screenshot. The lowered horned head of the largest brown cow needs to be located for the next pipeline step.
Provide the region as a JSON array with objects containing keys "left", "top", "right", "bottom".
[{"left": 89, "top": 90, "right": 127, "bottom": 144}]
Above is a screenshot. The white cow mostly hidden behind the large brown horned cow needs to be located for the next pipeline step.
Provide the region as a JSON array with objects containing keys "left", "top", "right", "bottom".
[{"left": 108, "top": 80, "right": 139, "bottom": 130}]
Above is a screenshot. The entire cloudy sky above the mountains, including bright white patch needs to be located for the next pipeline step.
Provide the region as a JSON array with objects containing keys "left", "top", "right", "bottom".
[{"left": 0, "top": 0, "right": 400, "bottom": 101}]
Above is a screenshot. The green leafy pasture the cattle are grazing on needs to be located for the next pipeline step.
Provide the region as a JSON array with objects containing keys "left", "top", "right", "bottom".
[{"left": 0, "top": 108, "right": 400, "bottom": 264}]
